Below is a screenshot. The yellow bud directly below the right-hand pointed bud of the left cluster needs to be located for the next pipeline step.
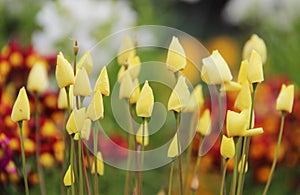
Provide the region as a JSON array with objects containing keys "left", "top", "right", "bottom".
[{"left": 86, "top": 91, "right": 104, "bottom": 121}]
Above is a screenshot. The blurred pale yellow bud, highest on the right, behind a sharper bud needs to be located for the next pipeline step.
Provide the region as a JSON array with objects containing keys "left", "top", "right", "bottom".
[{"left": 243, "top": 34, "right": 267, "bottom": 64}]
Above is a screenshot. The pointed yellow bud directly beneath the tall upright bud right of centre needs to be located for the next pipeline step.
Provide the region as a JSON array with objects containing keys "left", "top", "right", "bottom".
[{"left": 168, "top": 76, "right": 190, "bottom": 112}]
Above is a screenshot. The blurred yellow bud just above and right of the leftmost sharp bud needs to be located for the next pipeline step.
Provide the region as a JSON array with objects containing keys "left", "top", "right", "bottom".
[{"left": 27, "top": 62, "right": 49, "bottom": 93}]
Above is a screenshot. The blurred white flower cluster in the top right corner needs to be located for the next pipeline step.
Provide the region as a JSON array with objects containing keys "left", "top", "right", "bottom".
[{"left": 223, "top": 0, "right": 300, "bottom": 30}]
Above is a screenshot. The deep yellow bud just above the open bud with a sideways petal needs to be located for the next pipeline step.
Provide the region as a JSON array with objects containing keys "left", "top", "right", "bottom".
[{"left": 234, "top": 83, "right": 252, "bottom": 111}]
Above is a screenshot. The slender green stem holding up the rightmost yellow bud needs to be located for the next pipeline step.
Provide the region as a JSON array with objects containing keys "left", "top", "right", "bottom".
[{"left": 263, "top": 112, "right": 285, "bottom": 195}]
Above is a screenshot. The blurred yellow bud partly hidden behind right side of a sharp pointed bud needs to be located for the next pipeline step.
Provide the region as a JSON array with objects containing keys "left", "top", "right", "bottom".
[{"left": 184, "top": 84, "right": 204, "bottom": 112}]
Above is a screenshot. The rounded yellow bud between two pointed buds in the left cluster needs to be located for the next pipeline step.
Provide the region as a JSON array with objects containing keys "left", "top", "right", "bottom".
[{"left": 73, "top": 68, "right": 92, "bottom": 96}]
